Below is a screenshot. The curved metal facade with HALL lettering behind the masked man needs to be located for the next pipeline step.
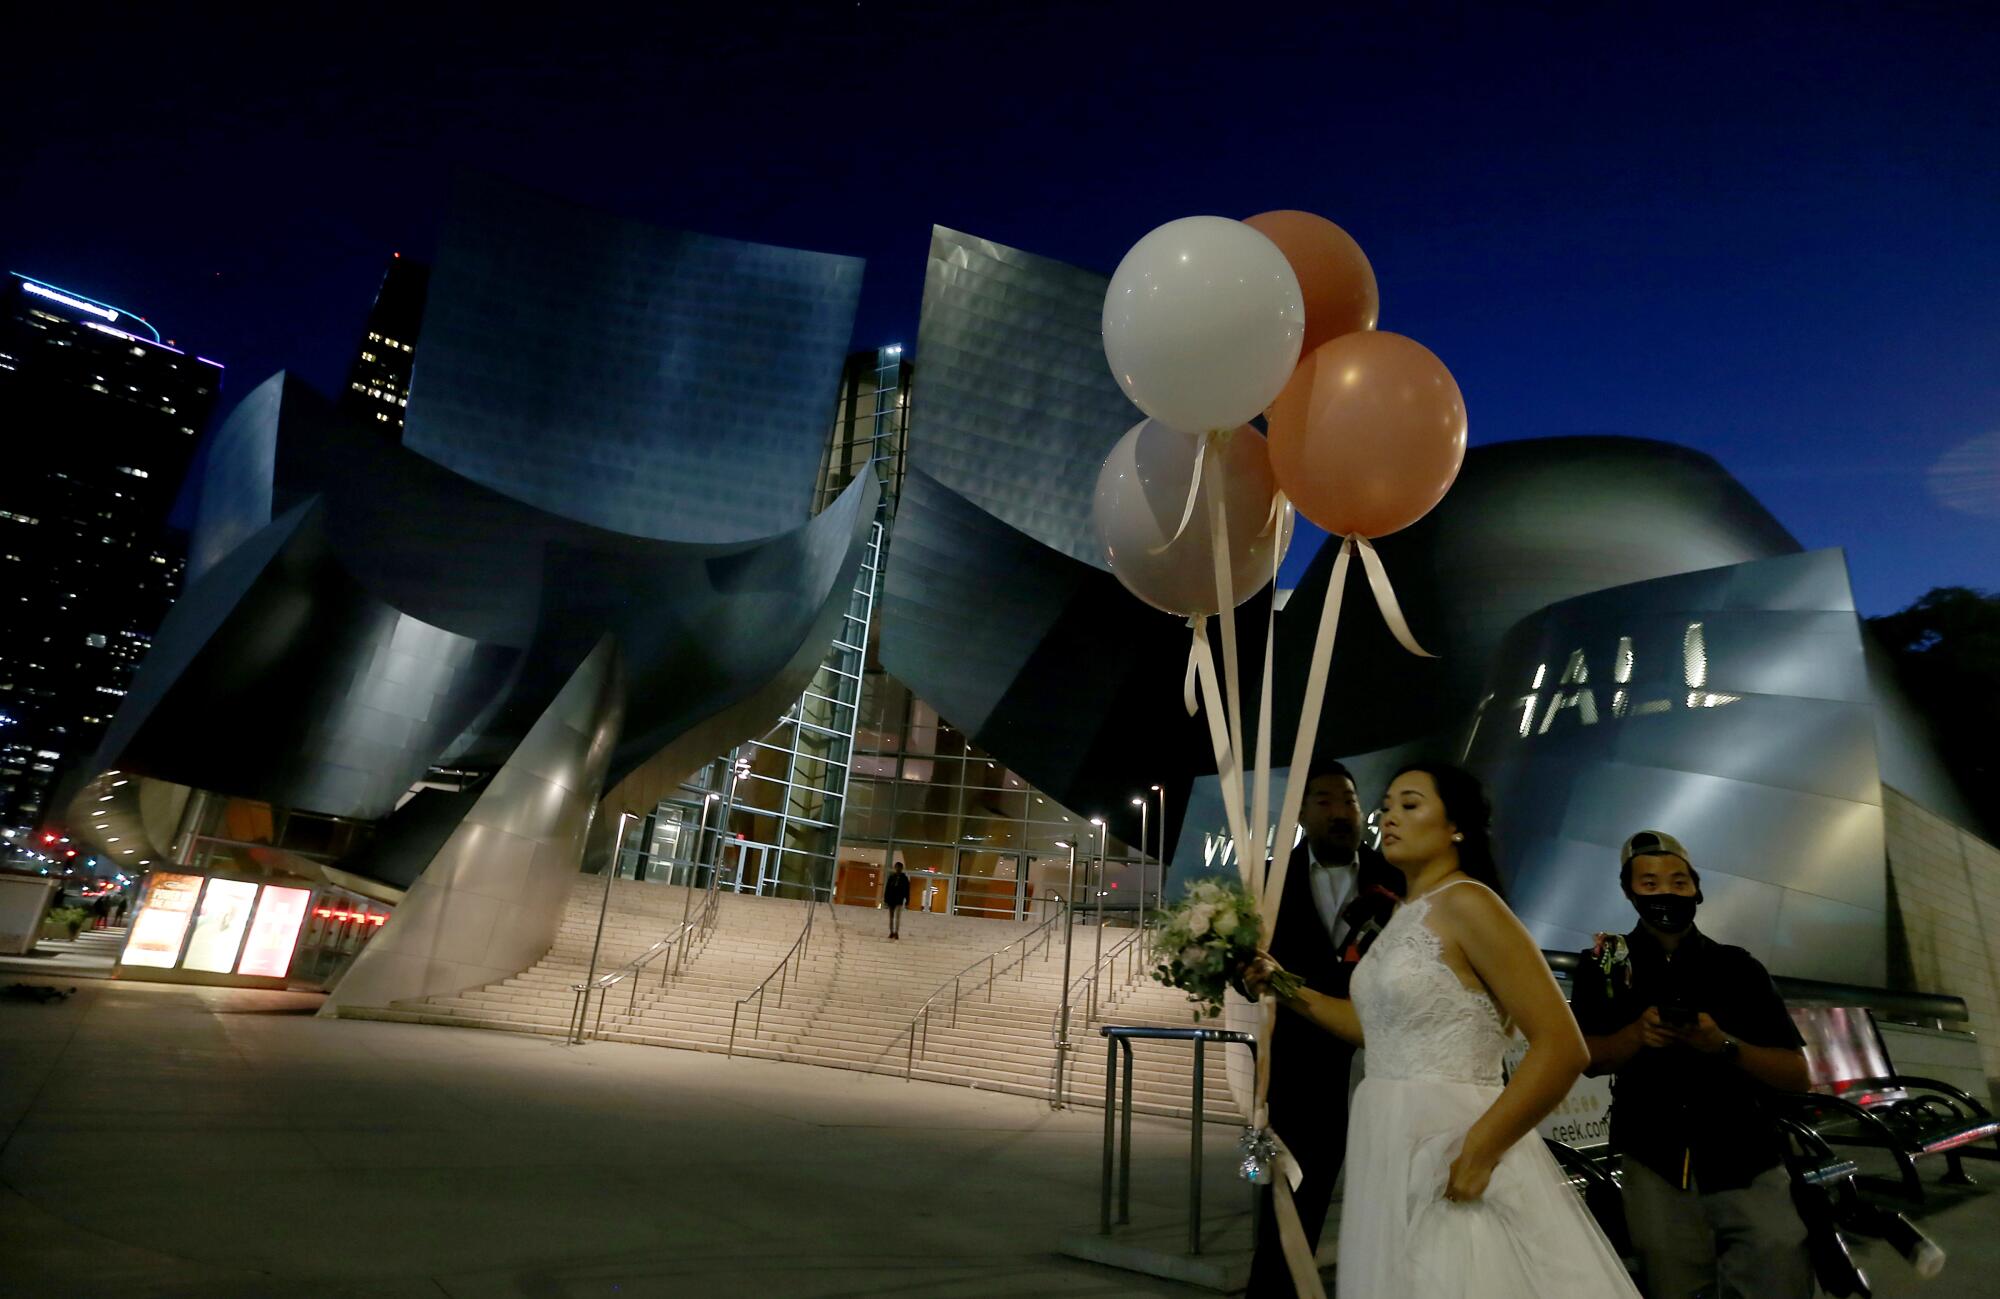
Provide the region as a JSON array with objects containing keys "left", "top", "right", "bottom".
[{"left": 1466, "top": 550, "right": 1888, "bottom": 983}]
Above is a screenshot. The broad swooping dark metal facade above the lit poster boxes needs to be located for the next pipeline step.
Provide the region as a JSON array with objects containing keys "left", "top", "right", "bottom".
[{"left": 98, "top": 376, "right": 878, "bottom": 819}]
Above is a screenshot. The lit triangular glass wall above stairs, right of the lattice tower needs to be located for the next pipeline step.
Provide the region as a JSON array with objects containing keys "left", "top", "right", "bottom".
[{"left": 834, "top": 669, "right": 1142, "bottom": 919}]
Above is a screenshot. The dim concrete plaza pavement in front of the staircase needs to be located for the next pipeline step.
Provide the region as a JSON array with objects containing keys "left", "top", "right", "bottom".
[{"left": 0, "top": 977, "right": 2000, "bottom": 1299}]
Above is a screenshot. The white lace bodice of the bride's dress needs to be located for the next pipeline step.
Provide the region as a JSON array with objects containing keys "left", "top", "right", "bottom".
[{"left": 1350, "top": 883, "right": 1508, "bottom": 1085}]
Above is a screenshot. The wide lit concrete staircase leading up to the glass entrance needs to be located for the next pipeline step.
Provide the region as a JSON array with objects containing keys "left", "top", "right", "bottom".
[{"left": 342, "top": 875, "right": 1236, "bottom": 1119}]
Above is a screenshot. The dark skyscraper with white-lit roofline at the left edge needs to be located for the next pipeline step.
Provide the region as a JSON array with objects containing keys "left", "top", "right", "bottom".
[{"left": 0, "top": 274, "right": 222, "bottom": 855}]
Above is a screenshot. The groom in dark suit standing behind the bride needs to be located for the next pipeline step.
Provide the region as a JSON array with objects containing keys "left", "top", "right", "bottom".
[{"left": 1246, "top": 759, "right": 1402, "bottom": 1299}]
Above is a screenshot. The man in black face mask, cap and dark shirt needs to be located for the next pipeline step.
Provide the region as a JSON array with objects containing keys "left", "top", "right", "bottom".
[{"left": 1570, "top": 829, "right": 1814, "bottom": 1299}]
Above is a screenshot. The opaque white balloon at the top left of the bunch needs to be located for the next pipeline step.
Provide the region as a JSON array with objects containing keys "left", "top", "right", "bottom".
[{"left": 1104, "top": 216, "right": 1306, "bottom": 432}]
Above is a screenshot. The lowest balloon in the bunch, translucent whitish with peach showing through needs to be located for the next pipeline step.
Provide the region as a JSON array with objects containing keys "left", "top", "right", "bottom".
[{"left": 1090, "top": 420, "right": 1292, "bottom": 616}]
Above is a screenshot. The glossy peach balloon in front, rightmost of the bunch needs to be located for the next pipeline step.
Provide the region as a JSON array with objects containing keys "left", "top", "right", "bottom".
[{"left": 1270, "top": 330, "right": 1466, "bottom": 538}]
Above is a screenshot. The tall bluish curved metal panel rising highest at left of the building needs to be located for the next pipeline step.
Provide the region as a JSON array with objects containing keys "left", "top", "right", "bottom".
[{"left": 404, "top": 176, "right": 862, "bottom": 542}]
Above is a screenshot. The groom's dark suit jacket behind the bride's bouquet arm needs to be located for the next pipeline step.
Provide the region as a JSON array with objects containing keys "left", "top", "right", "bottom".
[{"left": 1270, "top": 843, "right": 1402, "bottom": 1143}]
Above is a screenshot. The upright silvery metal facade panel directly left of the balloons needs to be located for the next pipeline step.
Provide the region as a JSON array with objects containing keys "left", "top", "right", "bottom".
[{"left": 910, "top": 226, "right": 1142, "bottom": 568}]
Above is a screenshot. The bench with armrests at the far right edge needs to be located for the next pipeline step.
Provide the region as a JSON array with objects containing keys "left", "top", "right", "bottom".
[{"left": 1782, "top": 1005, "right": 2000, "bottom": 1203}]
